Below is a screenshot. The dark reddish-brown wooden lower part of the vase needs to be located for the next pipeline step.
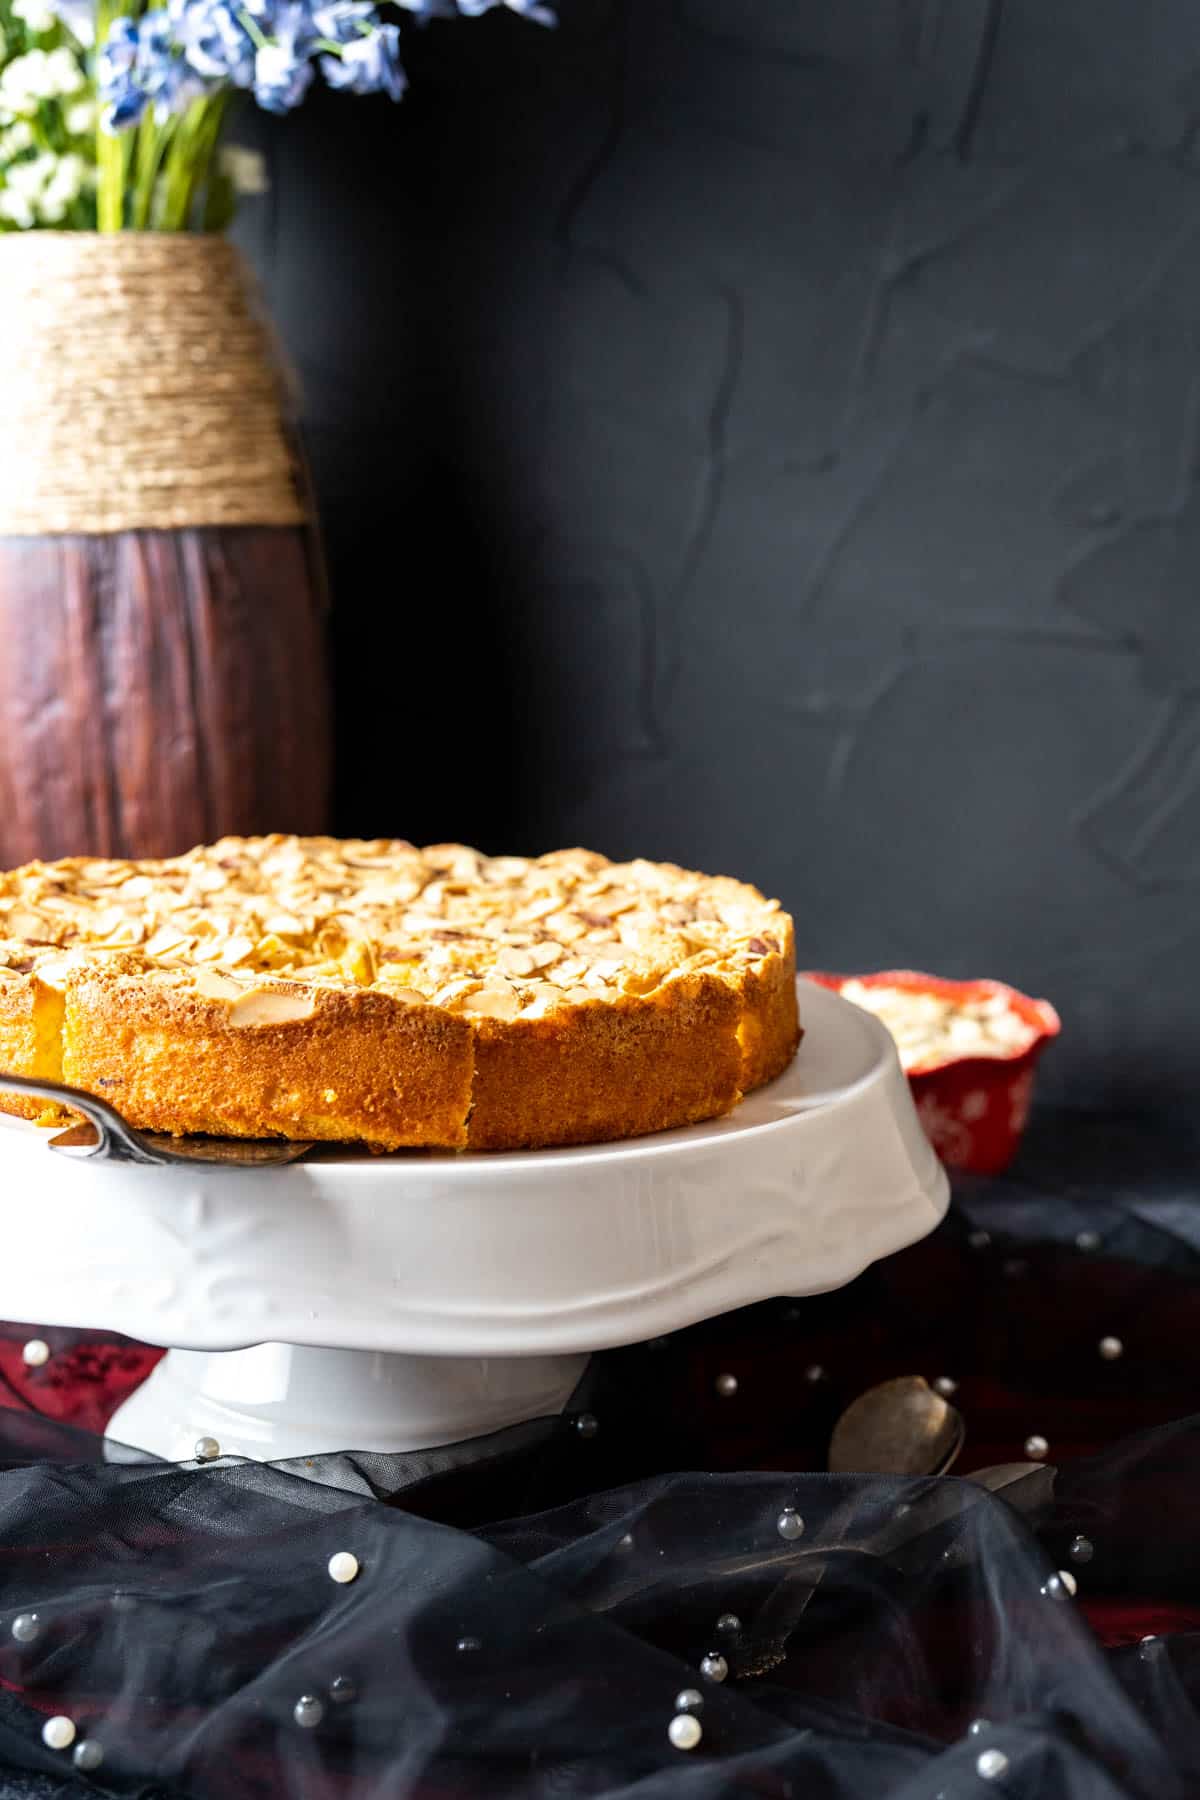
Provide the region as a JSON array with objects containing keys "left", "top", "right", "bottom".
[{"left": 0, "top": 526, "right": 329, "bottom": 868}]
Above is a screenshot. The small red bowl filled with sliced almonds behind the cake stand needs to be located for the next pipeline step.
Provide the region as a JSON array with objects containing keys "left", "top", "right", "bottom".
[{"left": 808, "top": 968, "right": 1061, "bottom": 1175}]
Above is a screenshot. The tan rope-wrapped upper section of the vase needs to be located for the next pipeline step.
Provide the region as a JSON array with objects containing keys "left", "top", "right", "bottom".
[{"left": 0, "top": 232, "right": 304, "bottom": 535}]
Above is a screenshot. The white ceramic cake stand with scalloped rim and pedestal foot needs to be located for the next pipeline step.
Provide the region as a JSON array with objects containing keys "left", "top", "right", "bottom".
[{"left": 0, "top": 983, "right": 948, "bottom": 1460}]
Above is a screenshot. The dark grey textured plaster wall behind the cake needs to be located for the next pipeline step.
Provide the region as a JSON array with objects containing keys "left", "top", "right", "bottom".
[{"left": 232, "top": 0, "right": 1200, "bottom": 1100}]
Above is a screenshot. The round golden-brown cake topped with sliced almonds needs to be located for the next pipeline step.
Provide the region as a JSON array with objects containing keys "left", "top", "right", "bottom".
[{"left": 0, "top": 837, "right": 799, "bottom": 1150}]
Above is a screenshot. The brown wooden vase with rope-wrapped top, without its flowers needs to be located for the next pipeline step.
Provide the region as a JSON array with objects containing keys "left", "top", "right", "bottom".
[{"left": 0, "top": 230, "right": 329, "bottom": 868}]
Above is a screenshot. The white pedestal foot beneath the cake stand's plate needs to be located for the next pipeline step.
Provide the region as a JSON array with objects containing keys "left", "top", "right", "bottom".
[{"left": 108, "top": 1343, "right": 588, "bottom": 1462}]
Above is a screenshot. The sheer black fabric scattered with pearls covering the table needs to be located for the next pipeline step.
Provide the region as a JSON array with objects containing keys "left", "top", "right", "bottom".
[{"left": 0, "top": 1120, "right": 1200, "bottom": 1800}]
